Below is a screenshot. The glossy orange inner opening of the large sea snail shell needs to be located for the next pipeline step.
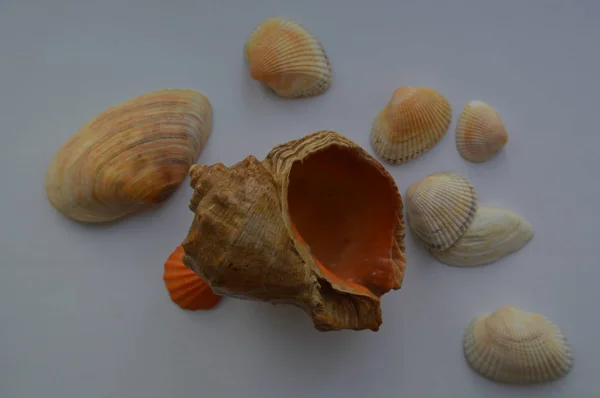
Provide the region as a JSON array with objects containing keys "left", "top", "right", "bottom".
[{"left": 288, "top": 146, "right": 399, "bottom": 296}]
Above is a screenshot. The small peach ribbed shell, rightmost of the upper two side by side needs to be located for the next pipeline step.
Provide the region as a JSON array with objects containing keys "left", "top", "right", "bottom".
[{"left": 456, "top": 101, "right": 508, "bottom": 162}]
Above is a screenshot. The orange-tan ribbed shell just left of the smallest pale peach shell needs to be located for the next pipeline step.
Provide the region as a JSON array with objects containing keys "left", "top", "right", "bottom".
[{"left": 371, "top": 86, "right": 452, "bottom": 164}]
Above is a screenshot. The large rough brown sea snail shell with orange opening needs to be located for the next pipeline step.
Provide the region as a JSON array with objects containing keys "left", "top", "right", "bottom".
[{"left": 182, "top": 131, "right": 405, "bottom": 331}]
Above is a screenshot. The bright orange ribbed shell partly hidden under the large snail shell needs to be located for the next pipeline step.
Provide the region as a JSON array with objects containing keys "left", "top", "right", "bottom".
[{"left": 163, "top": 246, "right": 221, "bottom": 311}]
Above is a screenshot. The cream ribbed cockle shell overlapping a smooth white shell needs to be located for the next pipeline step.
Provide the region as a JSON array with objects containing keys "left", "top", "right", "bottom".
[{"left": 406, "top": 171, "right": 477, "bottom": 251}]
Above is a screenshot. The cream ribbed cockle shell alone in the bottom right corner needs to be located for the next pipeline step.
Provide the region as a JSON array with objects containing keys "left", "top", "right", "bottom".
[{"left": 463, "top": 306, "right": 573, "bottom": 384}]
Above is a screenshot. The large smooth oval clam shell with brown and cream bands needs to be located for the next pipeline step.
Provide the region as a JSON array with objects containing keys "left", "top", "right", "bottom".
[{"left": 46, "top": 89, "right": 212, "bottom": 223}]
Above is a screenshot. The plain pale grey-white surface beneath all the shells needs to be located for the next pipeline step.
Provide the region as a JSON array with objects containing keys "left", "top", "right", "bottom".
[{"left": 0, "top": 0, "right": 600, "bottom": 398}]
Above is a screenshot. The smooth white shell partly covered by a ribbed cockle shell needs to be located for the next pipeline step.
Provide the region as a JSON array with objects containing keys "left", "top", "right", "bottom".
[{"left": 431, "top": 205, "right": 533, "bottom": 267}]
